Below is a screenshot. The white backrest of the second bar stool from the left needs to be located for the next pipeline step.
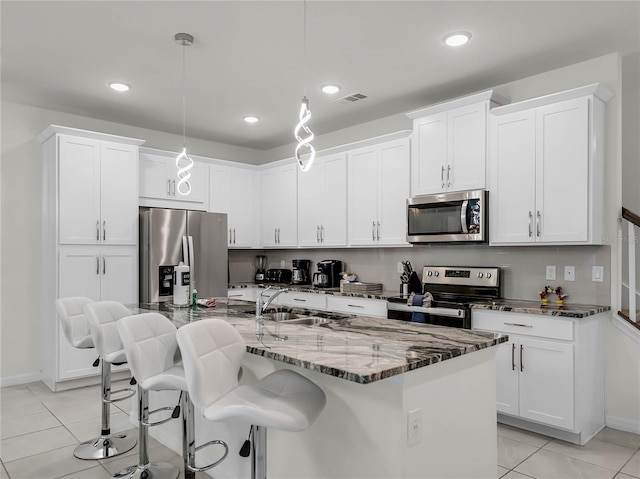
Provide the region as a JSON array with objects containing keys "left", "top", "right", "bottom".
[{"left": 84, "top": 301, "right": 131, "bottom": 358}]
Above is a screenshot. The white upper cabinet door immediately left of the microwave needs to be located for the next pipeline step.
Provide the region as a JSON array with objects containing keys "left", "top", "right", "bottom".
[{"left": 376, "top": 139, "right": 410, "bottom": 244}]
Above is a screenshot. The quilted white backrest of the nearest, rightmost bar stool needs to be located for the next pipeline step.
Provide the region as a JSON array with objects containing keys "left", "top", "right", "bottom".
[{"left": 176, "top": 318, "right": 247, "bottom": 409}]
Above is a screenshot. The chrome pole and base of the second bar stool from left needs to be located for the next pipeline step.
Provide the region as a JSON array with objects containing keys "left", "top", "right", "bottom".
[{"left": 112, "top": 384, "right": 178, "bottom": 479}]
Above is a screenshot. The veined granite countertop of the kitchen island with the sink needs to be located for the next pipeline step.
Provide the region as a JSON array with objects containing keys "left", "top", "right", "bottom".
[{"left": 130, "top": 298, "right": 508, "bottom": 384}]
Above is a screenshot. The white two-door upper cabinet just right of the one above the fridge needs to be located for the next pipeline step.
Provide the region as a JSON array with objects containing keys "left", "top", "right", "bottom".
[{"left": 209, "top": 164, "right": 260, "bottom": 248}]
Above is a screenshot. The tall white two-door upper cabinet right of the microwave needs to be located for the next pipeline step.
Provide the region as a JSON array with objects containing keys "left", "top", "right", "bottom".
[{"left": 489, "top": 85, "right": 611, "bottom": 244}]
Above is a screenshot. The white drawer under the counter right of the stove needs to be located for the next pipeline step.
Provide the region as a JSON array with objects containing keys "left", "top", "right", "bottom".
[{"left": 471, "top": 310, "right": 573, "bottom": 341}]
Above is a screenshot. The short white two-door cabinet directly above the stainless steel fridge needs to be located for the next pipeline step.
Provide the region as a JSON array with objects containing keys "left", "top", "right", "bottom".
[{"left": 140, "top": 148, "right": 209, "bottom": 211}]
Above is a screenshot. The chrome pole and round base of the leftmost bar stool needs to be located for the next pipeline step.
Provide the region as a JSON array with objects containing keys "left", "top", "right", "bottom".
[{"left": 73, "top": 359, "right": 136, "bottom": 459}]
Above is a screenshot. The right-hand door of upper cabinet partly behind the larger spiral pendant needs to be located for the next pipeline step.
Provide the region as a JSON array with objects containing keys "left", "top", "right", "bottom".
[{"left": 322, "top": 153, "right": 347, "bottom": 246}]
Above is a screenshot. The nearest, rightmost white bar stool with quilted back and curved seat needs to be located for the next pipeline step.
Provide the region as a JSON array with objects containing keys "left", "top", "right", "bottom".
[{"left": 176, "top": 318, "right": 326, "bottom": 479}]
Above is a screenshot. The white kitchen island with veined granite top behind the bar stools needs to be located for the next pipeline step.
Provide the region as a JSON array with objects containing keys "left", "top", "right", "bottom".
[{"left": 132, "top": 300, "right": 507, "bottom": 479}]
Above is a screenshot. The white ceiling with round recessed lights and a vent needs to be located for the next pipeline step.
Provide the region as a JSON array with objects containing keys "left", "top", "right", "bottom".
[{"left": 0, "top": 0, "right": 640, "bottom": 149}]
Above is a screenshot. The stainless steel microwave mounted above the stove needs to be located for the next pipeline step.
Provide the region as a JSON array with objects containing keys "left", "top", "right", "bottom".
[{"left": 407, "top": 190, "right": 489, "bottom": 244}]
